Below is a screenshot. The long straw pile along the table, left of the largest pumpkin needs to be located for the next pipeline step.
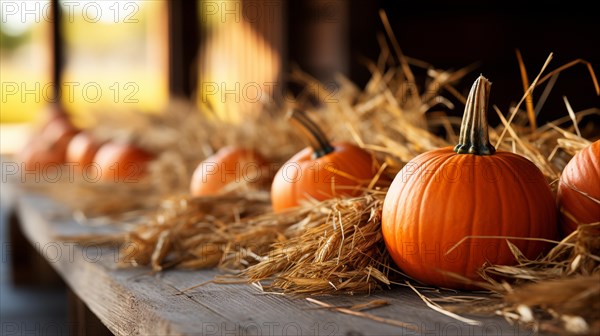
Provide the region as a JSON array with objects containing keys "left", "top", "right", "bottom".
[{"left": 108, "top": 192, "right": 390, "bottom": 295}]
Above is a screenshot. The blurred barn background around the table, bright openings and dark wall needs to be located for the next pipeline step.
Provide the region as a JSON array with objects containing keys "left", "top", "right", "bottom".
[{"left": 0, "top": 0, "right": 600, "bottom": 335}]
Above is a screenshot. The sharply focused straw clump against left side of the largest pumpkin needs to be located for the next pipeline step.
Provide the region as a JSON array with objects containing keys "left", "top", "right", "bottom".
[{"left": 242, "top": 195, "right": 390, "bottom": 295}]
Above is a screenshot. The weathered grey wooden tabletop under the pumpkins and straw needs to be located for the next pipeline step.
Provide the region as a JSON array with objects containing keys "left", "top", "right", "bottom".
[{"left": 4, "top": 184, "right": 533, "bottom": 335}]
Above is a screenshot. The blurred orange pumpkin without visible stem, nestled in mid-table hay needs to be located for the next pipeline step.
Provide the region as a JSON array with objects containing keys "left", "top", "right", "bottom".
[{"left": 190, "top": 146, "right": 267, "bottom": 196}]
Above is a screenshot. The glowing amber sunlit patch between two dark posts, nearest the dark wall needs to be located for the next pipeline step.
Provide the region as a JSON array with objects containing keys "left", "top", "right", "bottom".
[{"left": 197, "top": 0, "right": 284, "bottom": 121}]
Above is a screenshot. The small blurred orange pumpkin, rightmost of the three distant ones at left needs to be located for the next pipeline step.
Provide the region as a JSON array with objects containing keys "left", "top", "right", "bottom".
[{"left": 94, "top": 142, "right": 155, "bottom": 183}]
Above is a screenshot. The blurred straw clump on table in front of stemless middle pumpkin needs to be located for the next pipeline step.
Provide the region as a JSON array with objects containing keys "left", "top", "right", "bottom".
[{"left": 120, "top": 191, "right": 274, "bottom": 271}]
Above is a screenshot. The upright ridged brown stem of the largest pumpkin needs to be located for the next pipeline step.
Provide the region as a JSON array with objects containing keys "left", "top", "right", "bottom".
[{"left": 454, "top": 76, "right": 496, "bottom": 155}]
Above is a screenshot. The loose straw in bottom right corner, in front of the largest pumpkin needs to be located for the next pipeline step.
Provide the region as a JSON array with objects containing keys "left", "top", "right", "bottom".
[{"left": 438, "top": 222, "right": 600, "bottom": 335}]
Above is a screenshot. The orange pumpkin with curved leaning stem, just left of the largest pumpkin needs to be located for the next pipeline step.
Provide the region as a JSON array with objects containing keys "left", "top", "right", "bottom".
[{"left": 271, "top": 111, "right": 377, "bottom": 212}]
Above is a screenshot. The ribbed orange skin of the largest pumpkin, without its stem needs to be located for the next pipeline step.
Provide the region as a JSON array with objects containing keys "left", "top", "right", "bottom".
[{"left": 382, "top": 147, "right": 557, "bottom": 289}]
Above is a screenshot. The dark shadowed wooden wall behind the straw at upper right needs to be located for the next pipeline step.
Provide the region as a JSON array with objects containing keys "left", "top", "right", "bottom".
[{"left": 288, "top": 0, "right": 600, "bottom": 127}]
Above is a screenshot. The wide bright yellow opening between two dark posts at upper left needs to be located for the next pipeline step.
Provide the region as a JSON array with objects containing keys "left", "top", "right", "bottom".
[{"left": 60, "top": 1, "right": 168, "bottom": 114}]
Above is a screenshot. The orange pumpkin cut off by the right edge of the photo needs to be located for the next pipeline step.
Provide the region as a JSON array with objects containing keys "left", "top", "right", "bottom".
[{"left": 557, "top": 140, "right": 600, "bottom": 235}]
